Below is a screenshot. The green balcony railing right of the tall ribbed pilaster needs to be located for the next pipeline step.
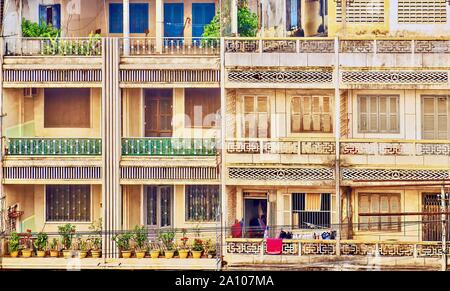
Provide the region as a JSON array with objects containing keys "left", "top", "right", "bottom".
[{"left": 122, "top": 137, "right": 217, "bottom": 156}]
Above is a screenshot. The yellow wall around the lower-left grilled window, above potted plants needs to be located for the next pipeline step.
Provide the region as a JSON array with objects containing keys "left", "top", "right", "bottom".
[{"left": 4, "top": 185, "right": 102, "bottom": 233}]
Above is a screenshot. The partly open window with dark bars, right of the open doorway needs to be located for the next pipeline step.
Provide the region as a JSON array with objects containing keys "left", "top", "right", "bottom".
[{"left": 292, "top": 193, "right": 331, "bottom": 229}]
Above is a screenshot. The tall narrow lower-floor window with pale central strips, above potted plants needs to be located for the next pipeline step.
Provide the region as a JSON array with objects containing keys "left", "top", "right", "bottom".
[{"left": 144, "top": 186, "right": 173, "bottom": 227}]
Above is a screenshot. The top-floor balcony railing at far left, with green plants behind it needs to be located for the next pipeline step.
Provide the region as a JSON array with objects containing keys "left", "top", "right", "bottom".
[{"left": 4, "top": 37, "right": 102, "bottom": 56}]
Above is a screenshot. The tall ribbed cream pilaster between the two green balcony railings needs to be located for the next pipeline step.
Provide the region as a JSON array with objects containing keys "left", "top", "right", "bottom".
[{"left": 102, "top": 38, "right": 122, "bottom": 257}]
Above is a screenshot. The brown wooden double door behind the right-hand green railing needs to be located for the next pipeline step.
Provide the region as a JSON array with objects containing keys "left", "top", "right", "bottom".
[{"left": 144, "top": 89, "right": 173, "bottom": 137}]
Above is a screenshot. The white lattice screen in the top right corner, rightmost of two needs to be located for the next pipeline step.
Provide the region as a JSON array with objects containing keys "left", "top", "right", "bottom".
[{"left": 398, "top": 0, "right": 447, "bottom": 23}]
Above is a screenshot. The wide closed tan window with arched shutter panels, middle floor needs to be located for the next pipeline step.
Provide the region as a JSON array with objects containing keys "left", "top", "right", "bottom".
[{"left": 291, "top": 96, "right": 333, "bottom": 133}]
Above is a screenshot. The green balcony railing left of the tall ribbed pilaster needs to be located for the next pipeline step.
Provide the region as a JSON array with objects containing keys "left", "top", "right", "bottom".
[{"left": 6, "top": 138, "right": 102, "bottom": 156}]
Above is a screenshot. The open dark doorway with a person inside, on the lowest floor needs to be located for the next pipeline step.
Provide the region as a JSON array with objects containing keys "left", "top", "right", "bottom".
[{"left": 244, "top": 197, "right": 268, "bottom": 238}]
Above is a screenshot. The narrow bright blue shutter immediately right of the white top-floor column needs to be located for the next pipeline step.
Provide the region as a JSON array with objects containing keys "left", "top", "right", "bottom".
[{"left": 164, "top": 3, "right": 184, "bottom": 37}]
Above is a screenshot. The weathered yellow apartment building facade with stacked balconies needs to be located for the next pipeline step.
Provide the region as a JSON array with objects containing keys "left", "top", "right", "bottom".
[{"left": 0, "top": 0, "right": 450, "bottom": 269}]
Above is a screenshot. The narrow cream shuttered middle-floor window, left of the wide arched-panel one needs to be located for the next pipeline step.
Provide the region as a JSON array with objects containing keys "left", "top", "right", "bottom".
[{"left": 244, "top": 96, "right": 270, "bottom": 138}]
